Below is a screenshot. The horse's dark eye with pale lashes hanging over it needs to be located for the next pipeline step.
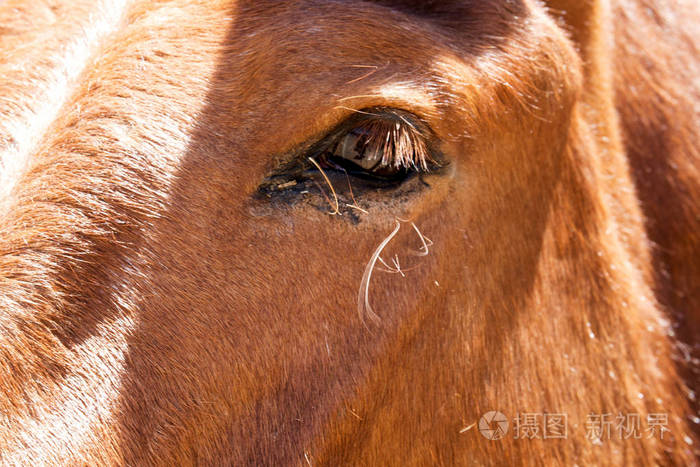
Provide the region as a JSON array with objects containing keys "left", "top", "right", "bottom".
[{"left": 320, "top": 111, "right": 434, "bottom": 178}]
